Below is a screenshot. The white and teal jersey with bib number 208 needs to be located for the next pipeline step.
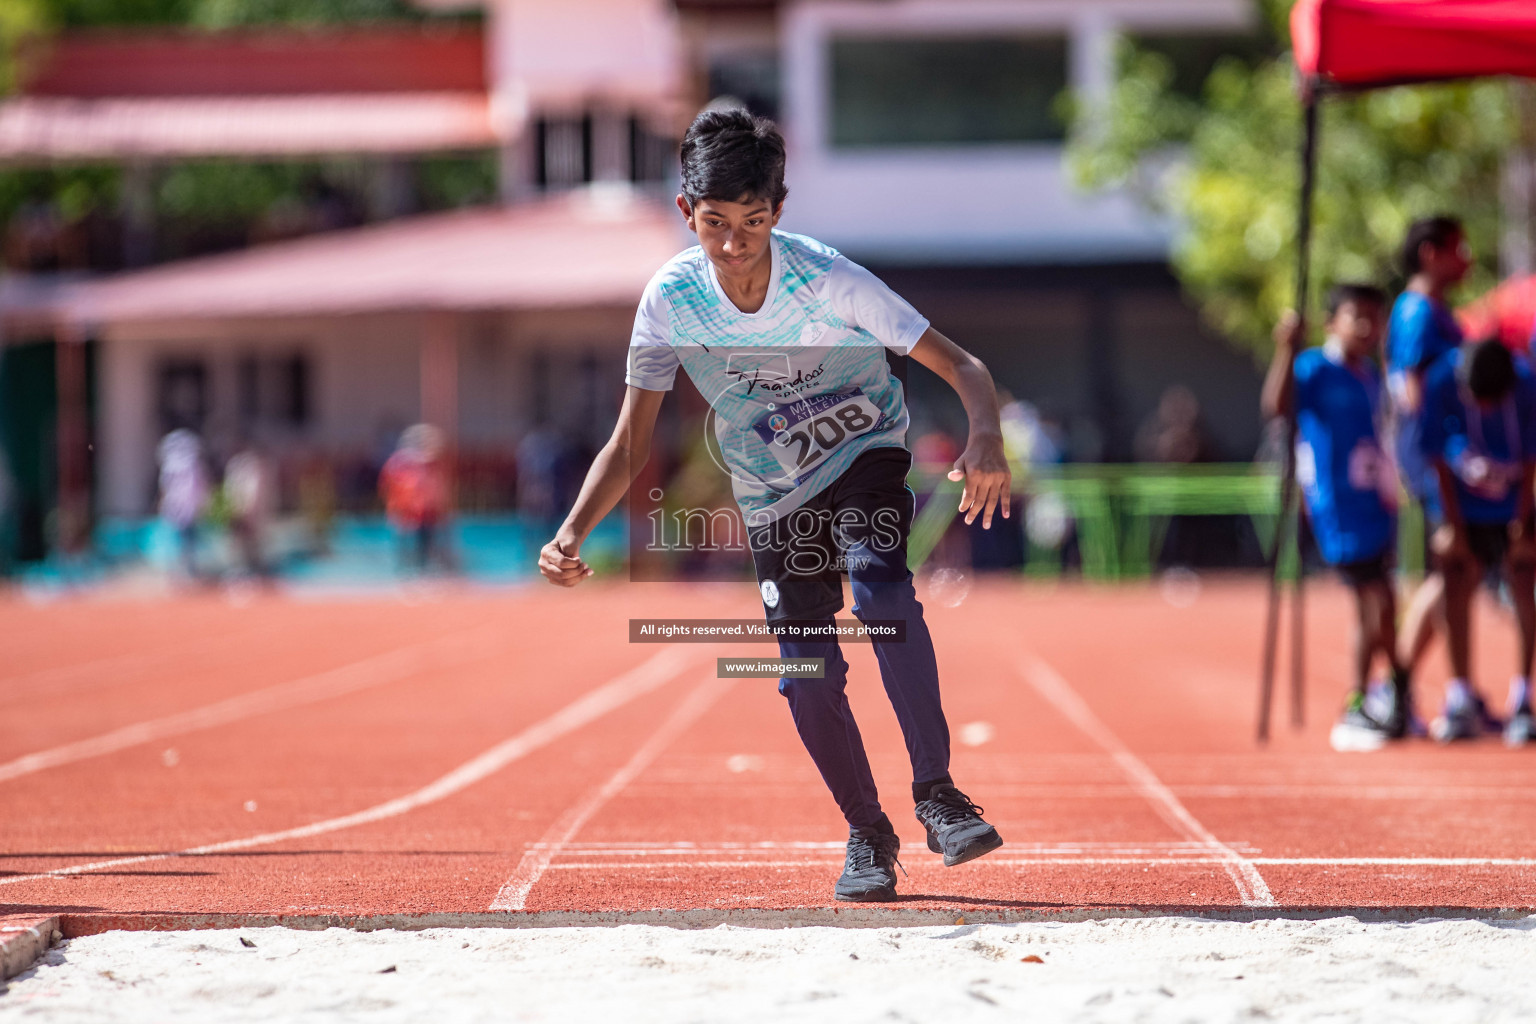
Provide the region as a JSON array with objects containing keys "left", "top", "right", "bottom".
[{"left": 625, "top": 232, "right": 928, "bottom": 525}]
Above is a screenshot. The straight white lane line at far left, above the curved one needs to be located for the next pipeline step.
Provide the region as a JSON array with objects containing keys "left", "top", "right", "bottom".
[{"left": 0, "top": 626, "right": 505, "bottom": 781}]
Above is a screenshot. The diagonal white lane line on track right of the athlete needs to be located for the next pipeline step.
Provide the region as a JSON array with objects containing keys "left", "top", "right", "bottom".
[{"left": 1018, "top": 654, "right": 1276, "bottom": 907}]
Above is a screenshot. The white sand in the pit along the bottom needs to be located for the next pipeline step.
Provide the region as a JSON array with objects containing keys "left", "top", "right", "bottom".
[{"left": 0, "top": 917, "right": 1536, "bottom": 1024}]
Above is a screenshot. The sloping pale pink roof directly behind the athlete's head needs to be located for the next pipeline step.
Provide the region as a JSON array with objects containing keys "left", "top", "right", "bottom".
[{"left": 61, "top": 189, "right": 687, "bottom": 330}]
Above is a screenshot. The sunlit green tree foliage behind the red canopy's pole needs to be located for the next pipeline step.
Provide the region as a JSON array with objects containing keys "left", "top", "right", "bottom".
[{"left": 1069, "top": 0, "right": 1516, "bottom": 355}]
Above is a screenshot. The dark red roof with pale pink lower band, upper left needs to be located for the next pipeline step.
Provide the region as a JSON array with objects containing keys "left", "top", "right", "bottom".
[{"left": 0, "top": 26, "right": 501, "bottom": 164}]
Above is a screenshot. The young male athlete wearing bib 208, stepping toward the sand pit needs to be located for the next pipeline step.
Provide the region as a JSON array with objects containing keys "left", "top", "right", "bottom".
[{"left": 539, "top": 111, "right": 1011, "bottom": 901}]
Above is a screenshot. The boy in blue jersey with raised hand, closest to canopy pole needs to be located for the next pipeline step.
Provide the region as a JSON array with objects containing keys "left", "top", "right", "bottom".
[{"left": 1263, "top": 284, "right": 1409, "bottom": 751}]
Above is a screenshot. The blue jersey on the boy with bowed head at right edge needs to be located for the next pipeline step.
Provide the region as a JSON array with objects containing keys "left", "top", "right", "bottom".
[{"left": 1419, "top": 350, "right": 1536, "bottom": 524}]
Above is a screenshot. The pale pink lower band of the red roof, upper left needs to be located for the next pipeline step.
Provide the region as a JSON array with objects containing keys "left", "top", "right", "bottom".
[{"left": 0, "top": 92, "right": 498, "bottom": 164}]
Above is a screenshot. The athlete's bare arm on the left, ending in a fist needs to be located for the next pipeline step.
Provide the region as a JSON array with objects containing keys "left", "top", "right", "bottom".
[{"left": 539, "top": 384, "right": 667, "bottom": 586}]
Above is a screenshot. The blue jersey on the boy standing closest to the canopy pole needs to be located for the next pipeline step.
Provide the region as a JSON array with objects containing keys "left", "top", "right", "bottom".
[{"left": 1295, "top": 342, "right": 1396, "bottom": 565}]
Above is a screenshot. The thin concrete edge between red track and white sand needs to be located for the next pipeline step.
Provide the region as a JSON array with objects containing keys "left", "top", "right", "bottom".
[{"left": 48, "top": 906, "right": 1536, "bottom": 939}]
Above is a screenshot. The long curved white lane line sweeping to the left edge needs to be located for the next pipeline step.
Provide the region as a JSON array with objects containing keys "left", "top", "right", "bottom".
[{"left": 0, "top": 648, "right": 693, "bottom": 886}]
